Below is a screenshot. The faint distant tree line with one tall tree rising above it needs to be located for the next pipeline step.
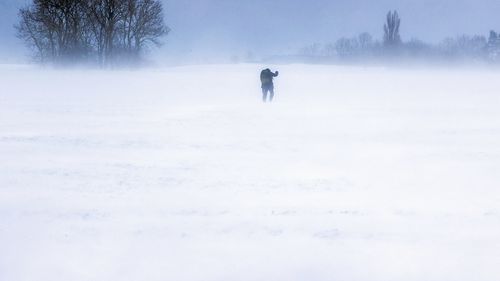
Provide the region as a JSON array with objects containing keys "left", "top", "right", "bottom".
[{"left": 299, "top": 11, "right": 500, "bottom": 63}]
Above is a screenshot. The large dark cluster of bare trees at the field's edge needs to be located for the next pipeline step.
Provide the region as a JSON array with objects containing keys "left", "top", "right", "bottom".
[{"left": 16, "top": 0, "right": 170, "bottom": 67}]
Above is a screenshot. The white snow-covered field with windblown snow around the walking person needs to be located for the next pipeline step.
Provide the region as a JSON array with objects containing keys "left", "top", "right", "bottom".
[{"left": 0, "top": 65, "right": 500, "bottom": 281}]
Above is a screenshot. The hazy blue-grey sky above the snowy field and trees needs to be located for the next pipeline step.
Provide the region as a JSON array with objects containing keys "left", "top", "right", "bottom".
[{"left": 0, "top": 0, "right": 500, "bottom": 61}]
